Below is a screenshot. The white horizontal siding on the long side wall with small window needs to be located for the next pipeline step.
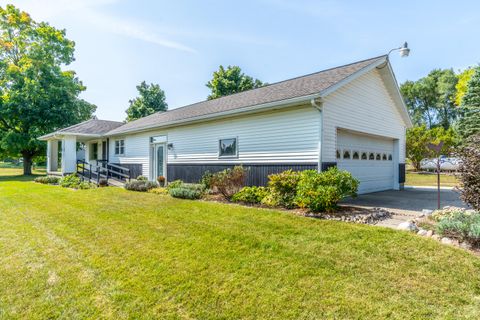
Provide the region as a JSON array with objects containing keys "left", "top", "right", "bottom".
[{"left": 110, "top": 105, "right": 320, "bottom": 176}]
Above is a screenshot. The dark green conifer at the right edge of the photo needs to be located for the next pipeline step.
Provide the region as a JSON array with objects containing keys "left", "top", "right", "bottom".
[{"left": 457, "top": 66, "right": 480, "bottom": 140}]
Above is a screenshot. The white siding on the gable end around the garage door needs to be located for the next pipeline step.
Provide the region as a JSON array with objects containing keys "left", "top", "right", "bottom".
[{"left": 322, "top": 70, "right": 405, "bottom": 163}]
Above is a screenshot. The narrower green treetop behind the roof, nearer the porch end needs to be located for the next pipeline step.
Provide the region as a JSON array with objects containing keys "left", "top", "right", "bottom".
[{"left": 126, "top": 81, "right": 168, "bottom": 121}]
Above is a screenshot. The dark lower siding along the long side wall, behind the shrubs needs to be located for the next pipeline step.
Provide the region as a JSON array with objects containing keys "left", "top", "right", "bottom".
[{"left": 167, "top": 163, "right": 318, "bottom": 186}]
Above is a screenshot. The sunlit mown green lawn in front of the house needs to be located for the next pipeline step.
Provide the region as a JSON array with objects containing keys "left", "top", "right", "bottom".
[{"left": 0, "top": 169, "right": 480, "bottom": 319}]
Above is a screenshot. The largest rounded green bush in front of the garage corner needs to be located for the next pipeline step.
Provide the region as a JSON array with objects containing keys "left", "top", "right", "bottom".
[{"left": 295, "top": 168, "right": 359, "bottom": 212}]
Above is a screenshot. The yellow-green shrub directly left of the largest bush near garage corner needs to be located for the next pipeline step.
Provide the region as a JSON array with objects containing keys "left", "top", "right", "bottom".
[{"left": 265, "top": 170, "right": 300, "bottom": 208}]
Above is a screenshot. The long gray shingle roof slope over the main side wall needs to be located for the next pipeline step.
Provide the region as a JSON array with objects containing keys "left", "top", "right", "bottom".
[{"left": 108, "top": 56, "right": 385, "bottom": 135}]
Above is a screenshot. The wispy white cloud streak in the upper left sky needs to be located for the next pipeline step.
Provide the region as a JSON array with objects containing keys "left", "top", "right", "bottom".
[{"left": 0, "top": 0, "right": 195, "bottom": 53}]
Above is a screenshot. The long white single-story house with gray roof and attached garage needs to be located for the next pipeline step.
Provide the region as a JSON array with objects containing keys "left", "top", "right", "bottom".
[{"left": 40, "top": 56, "right": 412, "bottom": 193}]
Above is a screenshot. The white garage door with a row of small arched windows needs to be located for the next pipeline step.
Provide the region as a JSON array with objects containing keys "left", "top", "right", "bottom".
[{"left": 337, "top": 130, "right": 394, "bottom": 193}]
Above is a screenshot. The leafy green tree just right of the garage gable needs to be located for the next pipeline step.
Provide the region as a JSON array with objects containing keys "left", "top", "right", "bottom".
[{"left": 400, "top": 69, "right": 458, "bottom": 129}]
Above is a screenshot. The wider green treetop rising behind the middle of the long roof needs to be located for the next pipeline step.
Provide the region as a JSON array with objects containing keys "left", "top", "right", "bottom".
[{"left": 206, "top": 66, "right": 266, "bottom": 100}]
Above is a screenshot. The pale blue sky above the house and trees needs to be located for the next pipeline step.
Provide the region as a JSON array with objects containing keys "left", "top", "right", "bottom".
[{"left": 0, "top": 0, "right": 480, "bottom": 120}]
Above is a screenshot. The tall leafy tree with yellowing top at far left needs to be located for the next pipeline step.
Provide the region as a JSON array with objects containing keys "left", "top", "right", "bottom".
[{"left": 0, "top": 5, "right": 96, "bottom": 174}]
